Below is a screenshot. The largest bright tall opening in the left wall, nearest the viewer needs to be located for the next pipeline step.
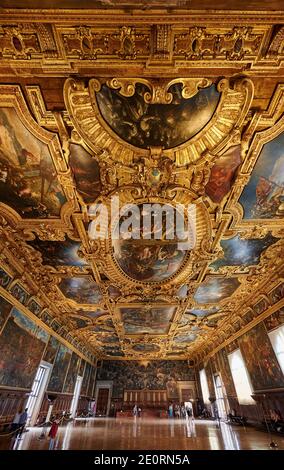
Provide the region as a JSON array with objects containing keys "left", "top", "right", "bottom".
[{"left": 26, "top": 362, "right": 52, "bottom": 426}]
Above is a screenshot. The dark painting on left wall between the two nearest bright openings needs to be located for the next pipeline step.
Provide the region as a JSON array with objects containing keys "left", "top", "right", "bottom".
[{"left": 47, "top": 344, "right": 72, "bottom": 393}]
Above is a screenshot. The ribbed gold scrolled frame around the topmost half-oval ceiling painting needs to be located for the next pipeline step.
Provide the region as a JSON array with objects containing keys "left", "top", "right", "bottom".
[{"left": 64, "top": 77, "right": 253, "bottom": 167}]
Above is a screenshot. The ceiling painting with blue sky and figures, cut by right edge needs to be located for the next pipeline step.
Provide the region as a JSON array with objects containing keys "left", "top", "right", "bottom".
[{"left": 240, "top": 133, "right": 284, "bottom": 219}]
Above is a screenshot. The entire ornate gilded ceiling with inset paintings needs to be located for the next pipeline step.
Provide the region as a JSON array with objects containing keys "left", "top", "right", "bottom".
[{"left": 0, "top": 2, "right": 284, "bottom": 359}]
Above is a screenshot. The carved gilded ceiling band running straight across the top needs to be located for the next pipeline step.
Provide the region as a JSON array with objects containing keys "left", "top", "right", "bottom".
[{"left": 0, "top": 9, "right": 283, "bottom": 76}]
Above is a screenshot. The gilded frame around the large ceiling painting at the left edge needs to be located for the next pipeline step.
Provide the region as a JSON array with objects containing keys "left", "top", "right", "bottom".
[{"left": 0, "top": 85, "right": 78, "bottom": 240}]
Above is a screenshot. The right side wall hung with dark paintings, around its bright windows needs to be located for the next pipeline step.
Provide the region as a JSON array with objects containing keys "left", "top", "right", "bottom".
[{"left": 197, "top": 298, "right": 284, "bottom": 422}]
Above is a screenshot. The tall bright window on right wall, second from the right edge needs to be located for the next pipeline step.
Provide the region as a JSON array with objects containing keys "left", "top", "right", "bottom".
[{"left": 228, "top": 349, "right": 255, "bottom": 405}]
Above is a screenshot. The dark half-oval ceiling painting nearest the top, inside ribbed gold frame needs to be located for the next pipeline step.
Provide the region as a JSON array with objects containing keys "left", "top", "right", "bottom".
[{"left": 96, "top": 84, "right": 220, "bottom": 149}]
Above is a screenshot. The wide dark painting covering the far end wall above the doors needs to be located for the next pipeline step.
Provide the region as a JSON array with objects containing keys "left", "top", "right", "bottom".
[{"left": 97, "top": 361, "right": 195, "bottom": 398}]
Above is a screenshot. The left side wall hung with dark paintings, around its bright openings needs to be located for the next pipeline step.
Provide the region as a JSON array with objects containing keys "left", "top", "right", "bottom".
[{"left": 0, "top": 268, "right": 96, "bottom": 426}]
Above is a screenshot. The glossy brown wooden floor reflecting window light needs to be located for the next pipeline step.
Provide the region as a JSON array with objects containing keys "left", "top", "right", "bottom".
[{"left": 0, "top": 418, "right": 284, "bottom": 450}]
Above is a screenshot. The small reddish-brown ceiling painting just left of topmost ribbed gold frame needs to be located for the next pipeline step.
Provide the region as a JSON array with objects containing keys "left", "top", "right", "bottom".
[{"left": 69, "top": 144, "right": 101, "bottom": 203}]
